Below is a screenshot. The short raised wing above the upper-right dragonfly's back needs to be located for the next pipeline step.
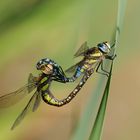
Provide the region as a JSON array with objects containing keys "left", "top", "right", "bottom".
[{"left": 74, "top": 42, "right": 89, "bottom": 57}]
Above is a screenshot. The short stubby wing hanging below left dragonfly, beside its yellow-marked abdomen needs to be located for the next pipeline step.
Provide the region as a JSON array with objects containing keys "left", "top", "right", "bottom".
[{"left": 32, "top": 91, "right": 41, "bottom": 112}]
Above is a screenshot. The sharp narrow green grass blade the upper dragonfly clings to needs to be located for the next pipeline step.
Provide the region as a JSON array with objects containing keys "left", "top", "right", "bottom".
[{"left": 89, "top": 0, "right": 127, "bottom": 140}]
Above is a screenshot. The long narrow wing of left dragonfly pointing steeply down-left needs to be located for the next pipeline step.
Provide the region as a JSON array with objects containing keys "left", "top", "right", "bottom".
[{"left": 11, "top": 92, "right": 38, "bottom": 130}]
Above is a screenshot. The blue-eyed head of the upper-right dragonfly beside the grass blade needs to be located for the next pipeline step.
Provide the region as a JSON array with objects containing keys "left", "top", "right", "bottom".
[{"left": 97, "top": 42, "right": 111, "bottom": 54}]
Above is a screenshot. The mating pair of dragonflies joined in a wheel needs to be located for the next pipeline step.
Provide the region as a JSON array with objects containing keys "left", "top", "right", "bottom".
[{"left": 0, "top": 42, "right": 116, "bottom": 129}]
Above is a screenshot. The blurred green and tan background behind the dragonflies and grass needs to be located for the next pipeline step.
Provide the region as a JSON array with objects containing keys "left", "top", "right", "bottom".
[{"left": 0, "top": 0, "right": 140, "bottom": 140}]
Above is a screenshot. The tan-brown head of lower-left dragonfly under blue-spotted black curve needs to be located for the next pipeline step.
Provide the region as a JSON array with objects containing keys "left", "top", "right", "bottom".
[{"left": 36, "top": 59, "right": 53, "bottom": 74}]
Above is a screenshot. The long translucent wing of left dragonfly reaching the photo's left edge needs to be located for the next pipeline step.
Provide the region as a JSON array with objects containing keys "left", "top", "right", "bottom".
[{"left": 0, "top": 76, "right": 36, "bottom": 108}]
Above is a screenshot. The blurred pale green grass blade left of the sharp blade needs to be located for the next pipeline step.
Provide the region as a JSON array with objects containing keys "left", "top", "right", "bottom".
[{"left": 72, "top": 77, "right": 106, "bottom": 140}]
